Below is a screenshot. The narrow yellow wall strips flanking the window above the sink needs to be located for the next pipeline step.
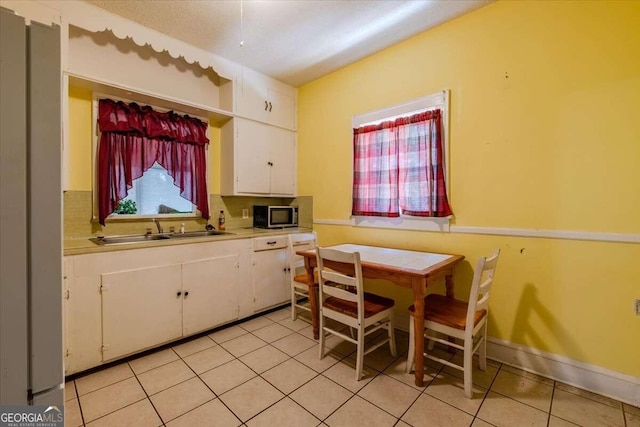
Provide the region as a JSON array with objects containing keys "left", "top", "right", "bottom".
[{"left": 66, "top": 87, "right": 220, "bottom": 194}]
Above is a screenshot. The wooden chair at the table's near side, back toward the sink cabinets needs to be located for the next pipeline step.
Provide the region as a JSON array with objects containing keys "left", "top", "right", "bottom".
[{"left": 316, "top": 248, "right": 396, "bottom": 381}]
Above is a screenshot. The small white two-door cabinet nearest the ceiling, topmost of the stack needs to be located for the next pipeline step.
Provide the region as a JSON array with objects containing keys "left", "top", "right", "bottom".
[{"left": 236, "top": 68, "right": 296, "bottom": 130}]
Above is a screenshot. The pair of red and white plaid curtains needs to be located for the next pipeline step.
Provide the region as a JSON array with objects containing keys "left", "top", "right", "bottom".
[{"left": 352, "top": 110, "right": 452, "bottom": 217}]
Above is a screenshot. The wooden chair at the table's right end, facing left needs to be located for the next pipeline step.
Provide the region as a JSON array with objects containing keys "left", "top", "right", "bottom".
[{"left": 406, "top": 249, "right": 500, "bottom": 399}]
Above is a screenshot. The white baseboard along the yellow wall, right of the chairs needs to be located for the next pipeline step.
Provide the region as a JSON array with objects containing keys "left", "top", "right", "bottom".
[{"left": 487, "top": 337, "right": 640, "bottom": 406}]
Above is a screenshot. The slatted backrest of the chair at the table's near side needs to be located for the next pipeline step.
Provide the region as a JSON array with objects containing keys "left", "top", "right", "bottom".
[{"left": 316, "top": 247, "right": 364, "bottom": 320}]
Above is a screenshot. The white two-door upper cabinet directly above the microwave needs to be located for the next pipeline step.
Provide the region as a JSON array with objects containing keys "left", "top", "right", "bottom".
[{"left": 221, "top": 118, "right": 296, "bottom": 197}]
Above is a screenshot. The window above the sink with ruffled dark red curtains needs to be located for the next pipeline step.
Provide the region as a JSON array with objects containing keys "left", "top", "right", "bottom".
[{"left": 95, "top": 98, "right": 209, "bottom": 225}]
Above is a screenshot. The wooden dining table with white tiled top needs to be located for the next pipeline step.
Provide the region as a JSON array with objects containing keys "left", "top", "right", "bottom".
[{"left": 296, "top": 243, "right": 464, "bottom": 387}]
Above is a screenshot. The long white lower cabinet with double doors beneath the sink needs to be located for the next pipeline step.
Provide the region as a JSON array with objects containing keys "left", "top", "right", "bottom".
[{"left": 64, "top": 239, "right": 253, "bottom": 375}]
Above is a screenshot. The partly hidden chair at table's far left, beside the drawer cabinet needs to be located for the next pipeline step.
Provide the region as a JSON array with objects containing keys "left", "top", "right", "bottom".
[{"left": 287, "top": 231, "right": 318, "bottom": 320}]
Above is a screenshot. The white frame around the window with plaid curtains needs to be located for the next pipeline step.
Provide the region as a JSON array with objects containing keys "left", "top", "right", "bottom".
[{"left": 350, "top": 89, "right": 452, "bottom": 232}]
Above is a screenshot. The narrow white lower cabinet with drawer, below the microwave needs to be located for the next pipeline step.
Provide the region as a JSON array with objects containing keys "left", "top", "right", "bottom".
[{"left": 253, "top": 236, "right": 291, "bottom": 312}]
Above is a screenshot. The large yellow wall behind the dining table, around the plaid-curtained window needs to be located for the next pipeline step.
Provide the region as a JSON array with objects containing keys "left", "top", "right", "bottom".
[{"left": 298, "top": 1, "right": 640, "bottom": 376}]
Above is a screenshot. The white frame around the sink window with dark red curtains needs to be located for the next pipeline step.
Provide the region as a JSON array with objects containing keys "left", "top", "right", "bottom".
[{"left": 91, "top": 92, "right": 210, "bottom": 222}]
